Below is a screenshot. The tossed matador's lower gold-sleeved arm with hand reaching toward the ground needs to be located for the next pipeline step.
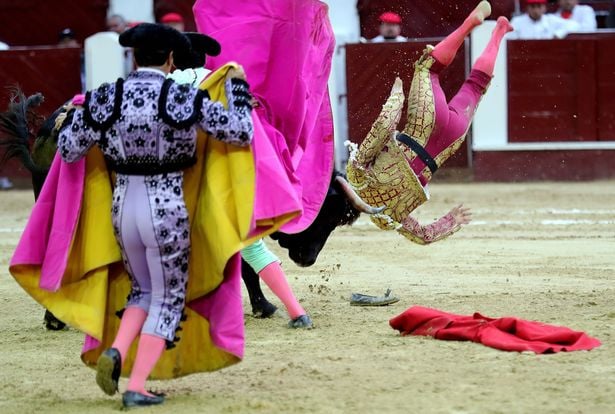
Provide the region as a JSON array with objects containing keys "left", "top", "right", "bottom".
[{"left": 397, "top": 205, "right": 471, "bottom": 244}]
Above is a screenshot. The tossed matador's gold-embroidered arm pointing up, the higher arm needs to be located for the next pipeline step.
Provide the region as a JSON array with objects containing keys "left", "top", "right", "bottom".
[{"left": 355, "top": 78, "right": 404, "bottom": 168}]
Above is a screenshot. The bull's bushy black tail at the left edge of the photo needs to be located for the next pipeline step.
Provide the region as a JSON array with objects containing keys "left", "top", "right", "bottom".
[{"left": 0, "top": 87, "right": 47, "bottom": 174}]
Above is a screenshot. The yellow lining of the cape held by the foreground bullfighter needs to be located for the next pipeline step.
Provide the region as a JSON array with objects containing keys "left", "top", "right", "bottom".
[{"left": 10, "top": 64, "right": 298, "bottom": 379}]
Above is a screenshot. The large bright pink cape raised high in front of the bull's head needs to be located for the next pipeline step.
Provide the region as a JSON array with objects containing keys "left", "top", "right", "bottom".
[{"left": 193, "top": 0, "right": 334, "bottom": 233}]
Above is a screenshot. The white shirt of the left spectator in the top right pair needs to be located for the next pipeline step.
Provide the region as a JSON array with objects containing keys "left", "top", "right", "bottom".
[{"left": 507, "top": 13, "right": 580, "bottom": 40}]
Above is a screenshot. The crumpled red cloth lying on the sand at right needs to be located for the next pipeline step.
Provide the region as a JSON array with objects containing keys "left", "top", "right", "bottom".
[{"left": 389, "top": 306, "right": 601, "bottom": 354}]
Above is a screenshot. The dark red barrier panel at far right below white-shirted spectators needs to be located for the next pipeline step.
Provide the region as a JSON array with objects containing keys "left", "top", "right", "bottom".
[{"left": 508, "top": 34, "right": 615, "bottom": 142}]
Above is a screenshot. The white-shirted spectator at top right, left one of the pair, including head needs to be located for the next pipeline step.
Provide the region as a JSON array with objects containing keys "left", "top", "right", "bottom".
[{"left": 507, "top": 0, "right": 580, "bottom": 39}]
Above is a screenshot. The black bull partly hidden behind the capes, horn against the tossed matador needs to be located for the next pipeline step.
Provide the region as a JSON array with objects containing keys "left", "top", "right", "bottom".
[{"left": 0, "top": 94, "right": 375, "bottom": 324}]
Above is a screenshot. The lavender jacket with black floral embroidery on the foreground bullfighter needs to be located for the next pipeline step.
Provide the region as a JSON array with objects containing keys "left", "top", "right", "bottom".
[{"left": 58, "top": 70, "right": 253, "bottom": 175}]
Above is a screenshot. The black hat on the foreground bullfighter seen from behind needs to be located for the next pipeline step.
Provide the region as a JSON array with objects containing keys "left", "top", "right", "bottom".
[{"left": 120, "top": 23, "right": 190, "bottom": 52}]
